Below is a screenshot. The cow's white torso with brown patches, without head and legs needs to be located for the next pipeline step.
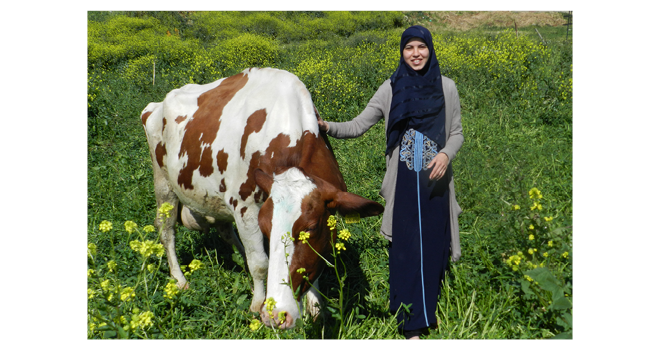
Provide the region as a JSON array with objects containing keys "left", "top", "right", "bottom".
[{"left": 142, "top": 69, "right": 318, "bottom": 220}]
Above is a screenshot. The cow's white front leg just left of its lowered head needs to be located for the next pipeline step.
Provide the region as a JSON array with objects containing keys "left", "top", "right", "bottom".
[{"left": 236, "top": 205, "right": 268, "bottom": 312}]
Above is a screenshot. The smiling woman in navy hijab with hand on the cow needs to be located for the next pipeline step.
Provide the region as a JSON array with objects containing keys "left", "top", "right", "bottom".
[{"left": 318, "top": 26, "right": 463, "bottom": 339}]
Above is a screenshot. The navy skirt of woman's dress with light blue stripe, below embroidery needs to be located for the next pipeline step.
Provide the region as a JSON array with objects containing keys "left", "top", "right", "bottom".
[{"left": 389, "top": 133, "right": 451, "bottom": 330}]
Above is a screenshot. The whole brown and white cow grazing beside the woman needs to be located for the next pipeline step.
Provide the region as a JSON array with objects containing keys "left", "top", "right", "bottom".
[{"left": 141, "top": 68, "right": 383, "bottom": 328}]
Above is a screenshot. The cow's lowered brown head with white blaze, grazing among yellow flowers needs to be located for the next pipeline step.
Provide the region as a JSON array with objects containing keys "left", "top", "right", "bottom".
[{"left": 255, "top": 167, "right": 384, "bottom": 328}]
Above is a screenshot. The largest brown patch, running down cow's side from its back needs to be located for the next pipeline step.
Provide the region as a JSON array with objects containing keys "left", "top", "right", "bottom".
[{"left": 177, "top": 73, "right": 248, "bottom": 189}]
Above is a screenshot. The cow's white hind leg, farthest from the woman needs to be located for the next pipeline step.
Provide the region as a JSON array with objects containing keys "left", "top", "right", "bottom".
[{"left": 154, "top": 166, "right": 187, "bottom": 288}]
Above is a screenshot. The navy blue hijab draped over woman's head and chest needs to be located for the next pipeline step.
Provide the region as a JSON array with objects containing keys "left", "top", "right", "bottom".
[{"left": 385, "top": 26, "right": 445, "bottom": 154}]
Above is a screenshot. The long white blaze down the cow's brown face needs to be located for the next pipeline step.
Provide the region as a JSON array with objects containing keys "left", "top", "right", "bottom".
[{"left": 267, "top": 168, "right": 316, "bottom": 319}]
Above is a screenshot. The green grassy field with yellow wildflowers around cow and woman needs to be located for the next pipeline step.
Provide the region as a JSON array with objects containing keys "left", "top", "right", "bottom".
[{"left": 87, "top": 12, "right": 573, "bottom": 339}]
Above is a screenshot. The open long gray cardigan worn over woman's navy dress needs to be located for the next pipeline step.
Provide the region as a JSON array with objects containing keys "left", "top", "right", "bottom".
[{"left": 328, "top": 76, "right": 463, "bottom": 262}]
